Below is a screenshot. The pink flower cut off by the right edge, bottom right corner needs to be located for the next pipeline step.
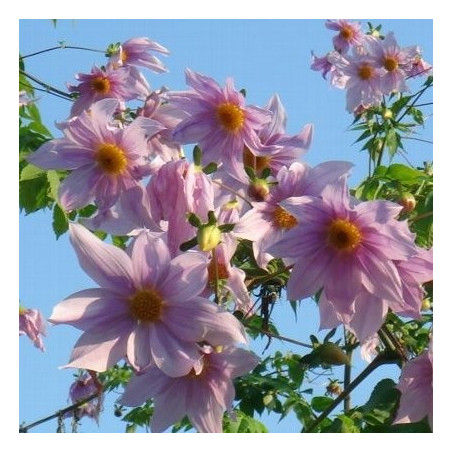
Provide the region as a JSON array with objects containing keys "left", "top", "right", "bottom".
[{"left": 393, "top": 339, "right": 433, "bottom": 430}]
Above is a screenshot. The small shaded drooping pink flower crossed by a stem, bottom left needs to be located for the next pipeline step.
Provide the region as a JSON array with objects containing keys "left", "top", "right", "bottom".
[{"left": 67, "top": 371, "right": 103, "bottom": 423}]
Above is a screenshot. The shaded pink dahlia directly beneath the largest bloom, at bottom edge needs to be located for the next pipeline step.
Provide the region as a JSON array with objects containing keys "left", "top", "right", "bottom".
[{"left": 119, "top": 347, "right": 259, "bottom": 433}]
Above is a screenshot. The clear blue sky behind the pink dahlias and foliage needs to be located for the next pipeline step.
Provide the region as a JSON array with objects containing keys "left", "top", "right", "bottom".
[{"left": 19, "top": 19, "right": 433, "bottom": 432}]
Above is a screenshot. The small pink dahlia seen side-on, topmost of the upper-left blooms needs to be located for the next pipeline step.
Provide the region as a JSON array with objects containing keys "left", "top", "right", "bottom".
[{"left": 110, "top": 37, "right": 169, "bottom": 72}]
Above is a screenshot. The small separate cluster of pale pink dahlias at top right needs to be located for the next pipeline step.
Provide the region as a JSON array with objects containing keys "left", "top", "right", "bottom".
[{"left": 311, "top": 20, "right": 431, "bottom": 113}]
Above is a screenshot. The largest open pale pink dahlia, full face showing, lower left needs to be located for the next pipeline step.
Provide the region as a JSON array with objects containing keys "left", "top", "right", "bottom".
[{"left": 50, "top": 224, "right": 246, "bottom": 377}]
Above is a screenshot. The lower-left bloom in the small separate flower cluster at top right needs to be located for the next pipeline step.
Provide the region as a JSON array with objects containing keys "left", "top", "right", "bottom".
[{"left": 328, "top": 52, "right": 385, "bottom": 113}]
